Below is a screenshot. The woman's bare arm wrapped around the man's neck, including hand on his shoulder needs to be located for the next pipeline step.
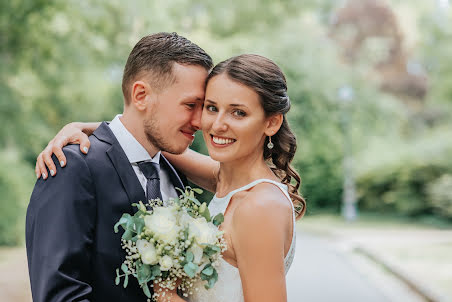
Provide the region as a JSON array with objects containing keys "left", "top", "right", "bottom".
[{"left": 35, "top": 122, "right": 219, "bottom": 192}]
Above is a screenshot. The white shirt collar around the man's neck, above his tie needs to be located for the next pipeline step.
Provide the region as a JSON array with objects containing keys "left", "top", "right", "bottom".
[{"left": 109, "top": 114, "right": 160, "bottom": 164}]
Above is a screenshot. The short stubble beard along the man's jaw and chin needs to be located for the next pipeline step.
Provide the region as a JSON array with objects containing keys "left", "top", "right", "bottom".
[{"left": 143, "top": 116, "right": 188, "bottom": 154}]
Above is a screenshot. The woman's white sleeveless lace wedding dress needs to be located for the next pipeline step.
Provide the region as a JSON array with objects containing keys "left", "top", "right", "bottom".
[{"left": 189, "top": 179, "right": 295, "bottom": 302}]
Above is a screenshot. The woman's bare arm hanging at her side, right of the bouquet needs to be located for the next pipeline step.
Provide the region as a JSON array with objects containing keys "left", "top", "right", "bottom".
[{"left": 231, "top": 191, "right": 292, "bottom": 302}]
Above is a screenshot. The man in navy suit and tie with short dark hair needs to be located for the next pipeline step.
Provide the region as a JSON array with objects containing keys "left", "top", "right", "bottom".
[{"left": 26, "top": 33, "right": 212, "bottom": 302}]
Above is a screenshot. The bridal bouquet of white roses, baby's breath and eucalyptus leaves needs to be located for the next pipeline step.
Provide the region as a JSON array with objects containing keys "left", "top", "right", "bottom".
[{"left": 114, "top": 187, "right": 226, "bottom": 299}]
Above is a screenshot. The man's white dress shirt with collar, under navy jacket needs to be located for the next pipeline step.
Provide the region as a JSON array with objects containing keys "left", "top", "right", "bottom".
[{"left": 110, "top": 114, "right": 178, "bottom": 202}]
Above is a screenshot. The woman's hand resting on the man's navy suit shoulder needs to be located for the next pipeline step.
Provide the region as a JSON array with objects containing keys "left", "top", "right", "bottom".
[{"left": 35, "top": 122, "right": 100, "bottom": 179}]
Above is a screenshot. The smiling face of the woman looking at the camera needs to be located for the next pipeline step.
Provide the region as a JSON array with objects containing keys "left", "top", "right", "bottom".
[{"left": 201, "top": 74, "right": 268, "bottom": 162}]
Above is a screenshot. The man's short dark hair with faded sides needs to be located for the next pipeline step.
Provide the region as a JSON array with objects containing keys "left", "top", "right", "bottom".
[{"left": 122, "top": 32, "right": 213, "bottom": 104}]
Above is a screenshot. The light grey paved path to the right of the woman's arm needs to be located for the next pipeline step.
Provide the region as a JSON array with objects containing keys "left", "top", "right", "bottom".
[{"left": 287, "top": 232, "right": 422, "bottom": 302}]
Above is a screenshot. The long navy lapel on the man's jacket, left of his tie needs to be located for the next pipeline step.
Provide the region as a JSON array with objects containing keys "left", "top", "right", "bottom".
[{"left": 93, "top": 122, "right": 146, "bottom": 208}]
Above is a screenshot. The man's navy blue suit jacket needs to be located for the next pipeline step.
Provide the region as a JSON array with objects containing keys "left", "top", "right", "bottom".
[{"left": 26, "top": 122, "right": 185, "bottom": 302}]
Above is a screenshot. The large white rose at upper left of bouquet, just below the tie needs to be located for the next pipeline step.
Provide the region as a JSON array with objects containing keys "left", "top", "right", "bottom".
[{"left": 144, "top": 207, "right": 180, "bottom": 243}]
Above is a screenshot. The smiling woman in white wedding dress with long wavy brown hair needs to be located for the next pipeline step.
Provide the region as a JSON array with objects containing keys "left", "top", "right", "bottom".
[{"left": 36, "top": 55, "right": 306, "bottom": 302}]
